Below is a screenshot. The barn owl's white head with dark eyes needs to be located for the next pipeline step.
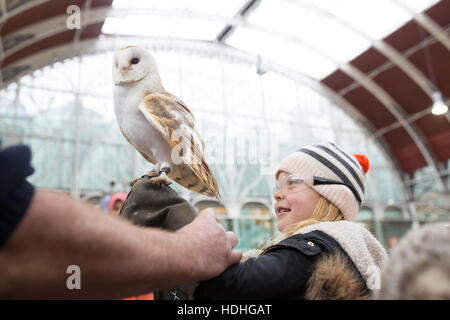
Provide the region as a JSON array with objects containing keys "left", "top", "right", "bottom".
[{"left": 113, "top": 46, "right": 159, "bottom": 85}]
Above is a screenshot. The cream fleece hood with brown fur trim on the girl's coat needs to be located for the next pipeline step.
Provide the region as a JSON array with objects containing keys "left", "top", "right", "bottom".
[{"left": 243, "top": 221, "right": 387, "bottom": 300}]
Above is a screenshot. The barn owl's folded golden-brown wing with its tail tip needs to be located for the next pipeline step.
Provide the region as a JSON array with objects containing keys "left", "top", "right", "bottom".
[{"left": 139, "top": 93, "right": 220, "bottom": 199}]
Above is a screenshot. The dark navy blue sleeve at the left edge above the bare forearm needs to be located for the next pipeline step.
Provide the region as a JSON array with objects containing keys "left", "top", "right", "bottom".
[{"left": 0, "top": 145, "right": 34, "bottom": 248}]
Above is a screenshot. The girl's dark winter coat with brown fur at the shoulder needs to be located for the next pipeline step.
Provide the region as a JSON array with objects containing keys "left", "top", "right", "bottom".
[{"left": 194, "top": 231, "right": 370, "bottom": 300}]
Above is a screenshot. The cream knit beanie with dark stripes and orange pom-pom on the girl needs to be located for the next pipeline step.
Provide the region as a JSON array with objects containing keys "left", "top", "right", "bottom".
[{"left": 275, "top": 142, "right": 369, "bottom": 221}]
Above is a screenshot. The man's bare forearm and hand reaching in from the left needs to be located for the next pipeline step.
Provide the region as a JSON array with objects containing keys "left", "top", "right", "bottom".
[{"left": 0, "top": 190, "right": 241, "bottom": 299}]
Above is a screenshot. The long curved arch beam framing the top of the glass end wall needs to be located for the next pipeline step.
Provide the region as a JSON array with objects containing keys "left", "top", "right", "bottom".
[{"left": 0, "top": 36, "right": 411, "bottom": 201}]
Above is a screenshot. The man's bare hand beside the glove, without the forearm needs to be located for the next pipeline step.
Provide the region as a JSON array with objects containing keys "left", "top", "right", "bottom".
[{"left": 175, "top": 208, "right": 242, "bottom": 280}]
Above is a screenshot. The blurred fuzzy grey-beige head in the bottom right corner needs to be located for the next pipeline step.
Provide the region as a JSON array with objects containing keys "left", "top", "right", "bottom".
[{"left": 376, "top": 223, "right": 450, "bottom": 300}]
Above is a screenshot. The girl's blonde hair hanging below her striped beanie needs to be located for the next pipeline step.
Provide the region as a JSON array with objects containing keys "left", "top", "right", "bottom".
[{"left": 266, "top": 197, "right": 344, "bottom": 247}]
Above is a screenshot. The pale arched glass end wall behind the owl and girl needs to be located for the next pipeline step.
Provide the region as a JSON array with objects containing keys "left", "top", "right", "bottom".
[{"left": 0, "top": 51, "right": 401, "bottom": 203}]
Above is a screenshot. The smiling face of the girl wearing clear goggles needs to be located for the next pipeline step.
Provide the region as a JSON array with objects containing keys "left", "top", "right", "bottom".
[{"left": 274, "top": 172, "right": 320, "bottom": 232}]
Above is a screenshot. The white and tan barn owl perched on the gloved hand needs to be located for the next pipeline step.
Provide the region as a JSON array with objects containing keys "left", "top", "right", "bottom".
[{"left": 113, "top": 46, "right": 220, "bottom": 199}]
